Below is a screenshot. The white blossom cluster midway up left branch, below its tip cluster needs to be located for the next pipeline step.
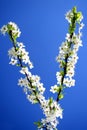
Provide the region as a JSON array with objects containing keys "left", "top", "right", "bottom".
[{"left": 8, "top": 42, "right": 33, "bottom": 69}]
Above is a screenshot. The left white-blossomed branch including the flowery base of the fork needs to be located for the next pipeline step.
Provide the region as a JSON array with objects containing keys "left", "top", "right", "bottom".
[{"left": 1, "top": 22, "right": 62, "bottom": 130}]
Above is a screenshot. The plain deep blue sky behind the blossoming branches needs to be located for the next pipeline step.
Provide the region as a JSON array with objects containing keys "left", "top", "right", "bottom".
[{"left": 0, "top": 0, "right": 87, "bottom": 130}]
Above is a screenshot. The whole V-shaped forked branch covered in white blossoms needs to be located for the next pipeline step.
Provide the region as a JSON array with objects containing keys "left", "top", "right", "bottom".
[{"left": 0, "top": 7, "right": 84, "bottom": 130}]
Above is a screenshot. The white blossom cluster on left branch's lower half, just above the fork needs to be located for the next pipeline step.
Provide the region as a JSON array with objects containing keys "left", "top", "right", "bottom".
[{"left": 18, "top": 70, "right": 45, "bottom": 103}]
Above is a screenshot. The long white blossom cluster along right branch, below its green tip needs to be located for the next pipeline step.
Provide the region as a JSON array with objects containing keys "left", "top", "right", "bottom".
[{"left": 56, "top": 27, "right": 82, "bottom": 87}]
